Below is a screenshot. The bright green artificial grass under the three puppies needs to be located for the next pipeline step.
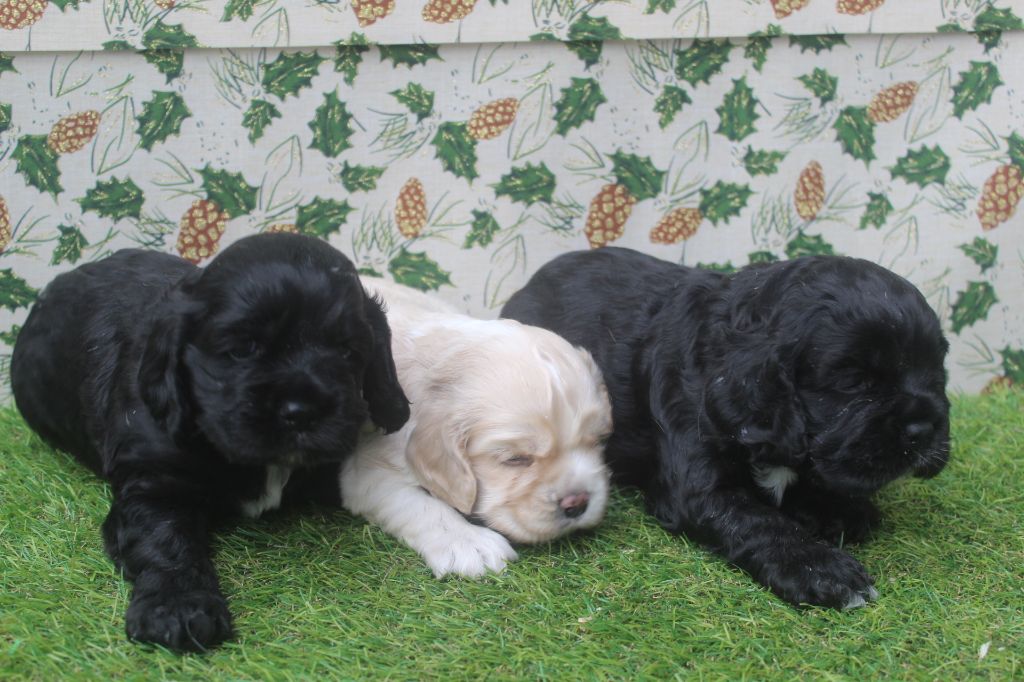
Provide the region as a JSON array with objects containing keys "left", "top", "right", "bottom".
[{"left": 0, "top": 392, "right": 1024, "bottom": 680}]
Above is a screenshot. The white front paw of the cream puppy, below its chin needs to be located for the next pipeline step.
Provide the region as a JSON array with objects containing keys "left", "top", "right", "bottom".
[{"left": 422, "top": 523, "right": 518, "bottom": 578}]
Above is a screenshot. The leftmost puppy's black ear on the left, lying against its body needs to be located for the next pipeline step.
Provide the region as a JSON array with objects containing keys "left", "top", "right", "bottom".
[{"left": 137, "top": 291, "right": 193, "bottom": 434}]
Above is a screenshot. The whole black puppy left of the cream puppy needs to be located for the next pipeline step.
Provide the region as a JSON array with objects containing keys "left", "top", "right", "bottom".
[{"left": 11, "top": 235, "right": 409, "bottom": 649}]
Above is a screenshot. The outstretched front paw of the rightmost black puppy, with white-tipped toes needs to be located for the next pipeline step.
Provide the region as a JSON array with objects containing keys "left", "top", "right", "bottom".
[{"left": 758, "top": 543, "right": 879, "bottom": 608}]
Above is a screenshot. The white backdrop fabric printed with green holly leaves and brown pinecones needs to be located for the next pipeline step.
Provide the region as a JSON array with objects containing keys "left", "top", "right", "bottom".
[{"left": 0, "top": 0, "right": 1024, "bottom": 391}]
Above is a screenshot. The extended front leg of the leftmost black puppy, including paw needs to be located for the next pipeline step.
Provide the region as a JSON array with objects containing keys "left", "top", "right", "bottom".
[{"left": 103, "top": 481, "right": 232, "bottom": 651}]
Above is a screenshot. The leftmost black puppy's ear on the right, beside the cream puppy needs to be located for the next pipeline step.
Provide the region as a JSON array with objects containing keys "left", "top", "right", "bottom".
[{"left": 362, "top": 296, "right": 409, "bottom": 433}]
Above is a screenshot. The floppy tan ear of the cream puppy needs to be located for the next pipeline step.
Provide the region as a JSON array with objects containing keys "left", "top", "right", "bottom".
[{"left": 406, "top": 410, "right": 476, "bottom": 515}]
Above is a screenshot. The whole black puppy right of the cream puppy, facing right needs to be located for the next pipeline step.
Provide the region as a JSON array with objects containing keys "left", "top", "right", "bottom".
[{"left": 502, "top": 248, "right": 949, "bottom": 607}]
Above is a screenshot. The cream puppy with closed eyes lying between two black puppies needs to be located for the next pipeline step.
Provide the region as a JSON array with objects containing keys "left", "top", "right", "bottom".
[{"left": 341, "top": 278, "right": 611, "bottom": 578}]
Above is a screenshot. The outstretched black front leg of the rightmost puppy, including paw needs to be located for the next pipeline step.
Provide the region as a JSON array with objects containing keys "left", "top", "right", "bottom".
[{"left": 648, "top": 432, "right": 878, "bottom": 608}]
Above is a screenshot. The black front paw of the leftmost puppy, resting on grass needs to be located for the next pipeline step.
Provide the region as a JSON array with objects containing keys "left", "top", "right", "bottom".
[{"left": 125, "top": 590, "right": 233, "bottom": 651}]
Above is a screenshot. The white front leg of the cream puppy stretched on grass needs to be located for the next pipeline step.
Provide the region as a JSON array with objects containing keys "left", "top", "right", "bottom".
[{"left": 341, "top": 438, "right": 517, "bottom": 578}]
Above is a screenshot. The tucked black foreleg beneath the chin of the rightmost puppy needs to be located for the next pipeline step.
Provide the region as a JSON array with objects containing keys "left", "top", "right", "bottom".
[{"left": 780, "top": 482, "right": 882, "bottom": 545}]
